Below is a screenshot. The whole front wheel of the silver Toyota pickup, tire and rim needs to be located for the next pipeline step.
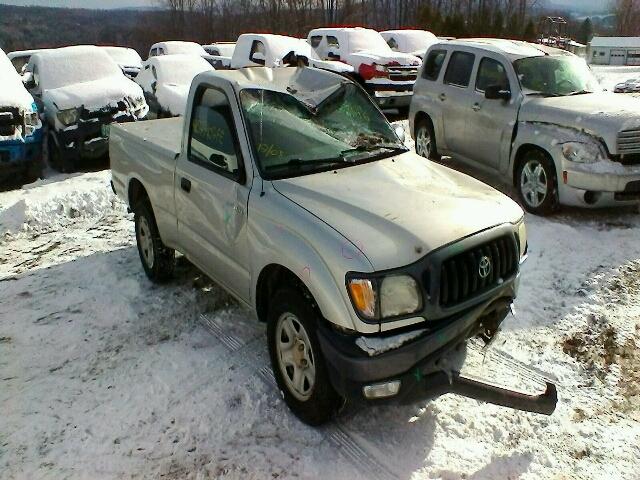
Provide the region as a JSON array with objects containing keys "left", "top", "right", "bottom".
[{"left": 267, "top": 288, "right": 343, "bottom": 425}]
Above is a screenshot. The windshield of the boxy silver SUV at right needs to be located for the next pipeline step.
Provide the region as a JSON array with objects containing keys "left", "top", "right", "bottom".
[{"left": 513, "top": 56, "right": 602, "bottom": 97}]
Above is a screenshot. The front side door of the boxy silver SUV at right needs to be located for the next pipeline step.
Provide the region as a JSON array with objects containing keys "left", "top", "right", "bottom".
[{"left": 463, "top": 57, "right": 518, "bottom": 170}]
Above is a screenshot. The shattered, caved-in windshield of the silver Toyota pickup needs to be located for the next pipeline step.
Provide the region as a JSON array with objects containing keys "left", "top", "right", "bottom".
[{"left": 240, "top": 82, "right": 406, "bottom": 179}]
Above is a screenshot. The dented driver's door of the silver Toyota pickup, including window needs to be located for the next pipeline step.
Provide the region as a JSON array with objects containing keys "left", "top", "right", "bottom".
[{"left": 175, "top": 87, "right": 250, "bottom": 301}]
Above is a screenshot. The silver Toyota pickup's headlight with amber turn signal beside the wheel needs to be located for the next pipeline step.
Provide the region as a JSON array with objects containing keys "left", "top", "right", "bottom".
[{"left": 347, "top": 275, "right": 422, "bottom": 320}]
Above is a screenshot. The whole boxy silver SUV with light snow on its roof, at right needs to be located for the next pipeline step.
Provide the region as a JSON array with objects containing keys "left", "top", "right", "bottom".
[{"left": 409, "top": 39, "right": 640, "bottom": 215}]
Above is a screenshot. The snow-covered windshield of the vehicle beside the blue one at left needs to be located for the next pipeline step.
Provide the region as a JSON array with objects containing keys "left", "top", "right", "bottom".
[{"left": 31, "top": 45, "right": 123, "bottom": 90}]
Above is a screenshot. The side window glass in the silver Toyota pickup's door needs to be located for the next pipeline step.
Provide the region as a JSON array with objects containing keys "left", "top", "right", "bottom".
[{"left": 188, "top": 88, "right": 244, "bottom": 181}]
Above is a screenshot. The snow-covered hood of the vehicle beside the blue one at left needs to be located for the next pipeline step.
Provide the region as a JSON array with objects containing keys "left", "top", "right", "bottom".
[{"left": 44, "top": 75, "right": 144, "bottom": 110}]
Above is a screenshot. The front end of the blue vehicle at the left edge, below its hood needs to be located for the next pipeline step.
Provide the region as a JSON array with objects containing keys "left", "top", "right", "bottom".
[{"left": 0, "top": 103, "right": 42, "bottom": 177}]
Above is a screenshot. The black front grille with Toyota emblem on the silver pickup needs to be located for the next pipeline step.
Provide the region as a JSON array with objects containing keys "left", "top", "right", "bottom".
[{"left": 440, "top": 235, "right": 519, "bottom": 308}]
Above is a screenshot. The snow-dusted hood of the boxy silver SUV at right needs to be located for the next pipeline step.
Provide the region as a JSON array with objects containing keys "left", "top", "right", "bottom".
[{"left": 519, "top": 92, "right": 640, "bottom": 154}]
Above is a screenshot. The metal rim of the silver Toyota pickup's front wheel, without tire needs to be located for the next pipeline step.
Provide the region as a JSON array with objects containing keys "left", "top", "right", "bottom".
[{"left": 276, "top": 312, "right": 316, "bottom": 402}]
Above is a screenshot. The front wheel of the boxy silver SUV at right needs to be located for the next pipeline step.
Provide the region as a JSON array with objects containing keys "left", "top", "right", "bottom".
[{"left": 515, "top": 149, "right": 559, "bottom": 216}]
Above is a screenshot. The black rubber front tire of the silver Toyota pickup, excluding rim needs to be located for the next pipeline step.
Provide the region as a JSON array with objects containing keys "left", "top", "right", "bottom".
[{"left": 267, "top": 287, "right": 344, "bottom": 426}]
